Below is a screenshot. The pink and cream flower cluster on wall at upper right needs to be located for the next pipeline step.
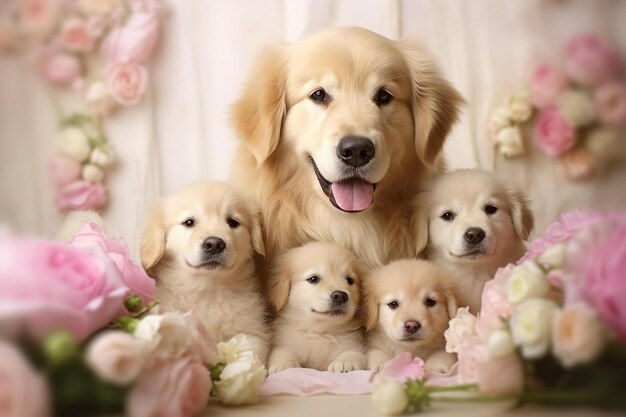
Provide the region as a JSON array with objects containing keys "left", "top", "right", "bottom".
[{"left": 488, "top": 35, "right": 626, "bottom": 180}]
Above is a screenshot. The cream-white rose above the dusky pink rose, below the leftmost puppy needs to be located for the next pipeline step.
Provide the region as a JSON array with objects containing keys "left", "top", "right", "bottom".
[{"left": 135, "top": 313, "right": 191, "bottom": 359}]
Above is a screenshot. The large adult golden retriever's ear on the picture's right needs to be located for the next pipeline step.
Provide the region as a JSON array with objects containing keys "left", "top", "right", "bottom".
[{"left": 397, "top": 39, "right": 464, "bottom": 170}]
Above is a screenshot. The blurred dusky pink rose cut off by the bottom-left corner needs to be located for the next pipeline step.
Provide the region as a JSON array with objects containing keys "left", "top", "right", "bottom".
[{"left": 0, "top": 339, "right": 51, "bottom": 417}]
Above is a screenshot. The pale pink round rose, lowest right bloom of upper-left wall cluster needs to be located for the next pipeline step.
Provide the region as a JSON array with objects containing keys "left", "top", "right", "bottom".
[{"left": 106, "top": 64, "right": 148, "bottom": 105}]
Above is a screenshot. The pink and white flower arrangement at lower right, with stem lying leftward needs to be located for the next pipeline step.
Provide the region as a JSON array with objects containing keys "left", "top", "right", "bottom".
[{"left": 373, "top": 212, "right": 626, "bottom": 414}]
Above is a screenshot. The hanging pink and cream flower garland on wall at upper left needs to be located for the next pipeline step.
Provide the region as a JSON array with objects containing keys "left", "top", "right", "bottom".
[{"left": 0, "top": 0, "right": 161, "bottom": 212}]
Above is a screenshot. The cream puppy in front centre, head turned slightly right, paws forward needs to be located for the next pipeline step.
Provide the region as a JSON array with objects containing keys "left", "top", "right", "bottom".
[{"left": 268, "top": 242, "right": 366, "bottom": 373}]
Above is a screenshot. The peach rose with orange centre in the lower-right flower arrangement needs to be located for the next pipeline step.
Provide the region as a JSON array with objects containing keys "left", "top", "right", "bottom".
[{"left": 552, "top": 304, "right": 609, "bottom": 368}]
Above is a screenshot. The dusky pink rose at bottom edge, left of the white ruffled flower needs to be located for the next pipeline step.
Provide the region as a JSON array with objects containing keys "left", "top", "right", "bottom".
[{"left": 126, "top": 356, "right": 212, "bottom": 417}]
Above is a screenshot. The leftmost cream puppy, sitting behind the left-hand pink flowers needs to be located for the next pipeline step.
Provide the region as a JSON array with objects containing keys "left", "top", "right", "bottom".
[{"left": 141, "top": 181, "right": 269, "bottom": 362}]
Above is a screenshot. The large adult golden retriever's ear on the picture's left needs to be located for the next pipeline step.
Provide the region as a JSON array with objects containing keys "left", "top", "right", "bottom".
[{"left": 233, "top": 44, "right": 287, "bottom": 166}]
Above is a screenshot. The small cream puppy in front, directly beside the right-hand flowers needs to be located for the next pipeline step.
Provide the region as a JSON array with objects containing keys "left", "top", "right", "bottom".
[{"left": 364, "top": 259, "right": 457, "bottom": 372}]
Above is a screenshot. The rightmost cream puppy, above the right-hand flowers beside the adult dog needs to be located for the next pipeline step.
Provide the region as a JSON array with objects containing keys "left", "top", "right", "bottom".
[{"left": 417, "top": 169, "right": 534, "bottom": 313}]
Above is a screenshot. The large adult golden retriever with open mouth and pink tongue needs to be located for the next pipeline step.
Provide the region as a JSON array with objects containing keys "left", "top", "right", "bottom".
[{"left": 231, "top": 28, "right": 462, "bottom": 265}]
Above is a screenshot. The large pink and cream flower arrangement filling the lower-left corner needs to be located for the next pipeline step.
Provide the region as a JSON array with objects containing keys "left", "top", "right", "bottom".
[{"left": 0, "top": 223, "right": 266, "bottom": 417}]
